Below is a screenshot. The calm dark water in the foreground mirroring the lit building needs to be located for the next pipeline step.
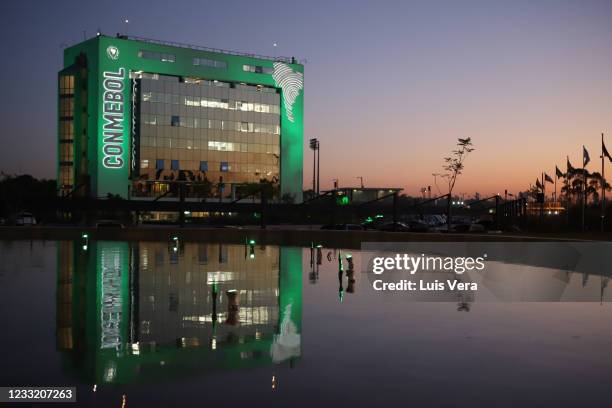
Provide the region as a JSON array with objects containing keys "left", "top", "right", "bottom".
[{"left": 0, "top": 239, "right": 612, "bottom": 407}]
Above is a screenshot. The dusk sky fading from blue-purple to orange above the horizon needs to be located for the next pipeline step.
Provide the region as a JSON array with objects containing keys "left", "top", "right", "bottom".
[{"left": 0, "top": 0, "right": 612, "bottom": 195}]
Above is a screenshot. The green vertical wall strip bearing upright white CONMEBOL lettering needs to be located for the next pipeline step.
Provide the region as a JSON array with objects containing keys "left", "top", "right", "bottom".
[{"left": 96, "top": 43, "right": 131, "bottom": 198}]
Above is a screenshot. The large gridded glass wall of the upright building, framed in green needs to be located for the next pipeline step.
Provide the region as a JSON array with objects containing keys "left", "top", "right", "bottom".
[{"left": 135, "top": 73, "right": 281, "bottom": 195}]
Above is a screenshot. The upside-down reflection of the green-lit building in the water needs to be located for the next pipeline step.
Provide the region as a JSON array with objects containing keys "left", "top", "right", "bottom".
[{"left": 57, "top": 240, "right": 302, "bottom": 384}]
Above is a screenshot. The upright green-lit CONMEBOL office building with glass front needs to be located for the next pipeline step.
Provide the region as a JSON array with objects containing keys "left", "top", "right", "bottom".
[{"left": 58, "top": 35, "right": 304, "bottom": 201}]
